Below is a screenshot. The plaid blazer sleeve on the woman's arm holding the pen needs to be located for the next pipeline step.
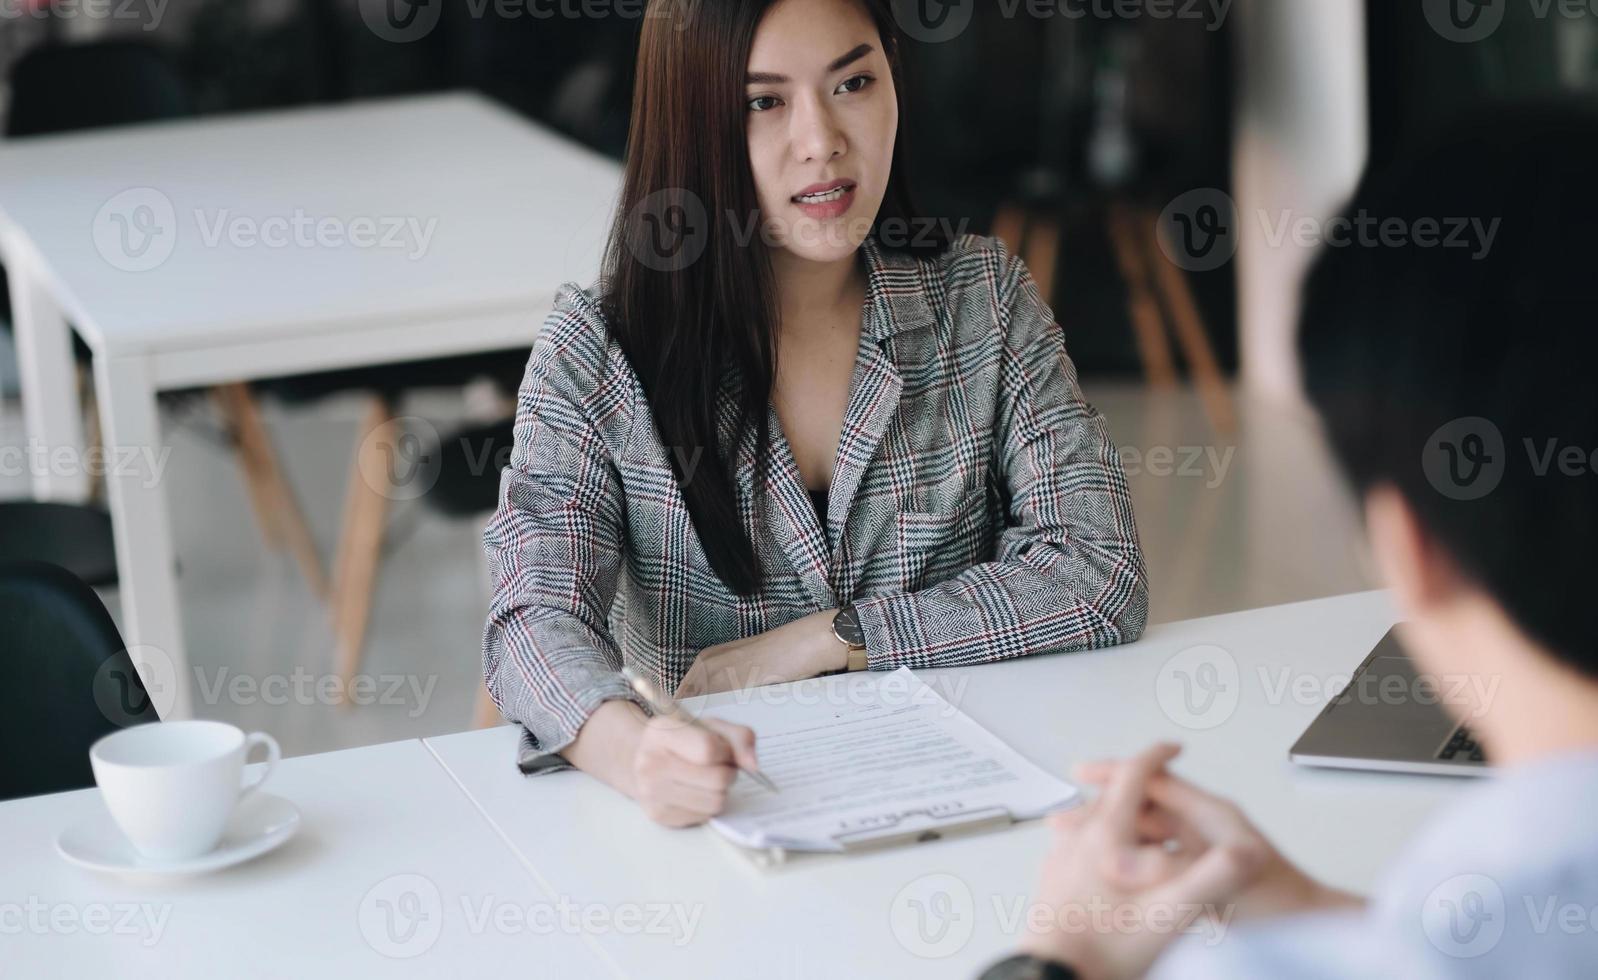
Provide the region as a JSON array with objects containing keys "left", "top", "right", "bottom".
[{"left": 483, "top": 295, "right": 642, "bottom": 753}]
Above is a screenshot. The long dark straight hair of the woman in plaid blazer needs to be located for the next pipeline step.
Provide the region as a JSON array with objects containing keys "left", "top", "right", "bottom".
[{"left": 601, "top": 0, "right": 949, "bottom": 596}]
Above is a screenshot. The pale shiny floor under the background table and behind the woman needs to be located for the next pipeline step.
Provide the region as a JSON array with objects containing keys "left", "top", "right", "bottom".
[{"left": 0, "top": 382, "right": 1369, "bottom": 755}]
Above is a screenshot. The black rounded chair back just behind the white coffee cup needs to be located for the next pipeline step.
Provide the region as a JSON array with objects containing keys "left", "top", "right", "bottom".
[{"left": 0, "top": 561, "right": 160, "bottom": 799}]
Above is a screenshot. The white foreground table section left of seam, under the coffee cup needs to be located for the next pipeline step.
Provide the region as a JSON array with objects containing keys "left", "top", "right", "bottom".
[{"left": 0, "top": 740, "right": 617, "bottom": 980}]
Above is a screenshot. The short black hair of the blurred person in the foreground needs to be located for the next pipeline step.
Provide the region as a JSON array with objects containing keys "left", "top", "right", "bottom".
[{"left": 1299, "top": 101, "right": 1598, "bottom": 678}]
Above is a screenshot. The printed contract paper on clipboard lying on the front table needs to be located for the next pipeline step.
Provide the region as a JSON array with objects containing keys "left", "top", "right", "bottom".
[{"left": 700, "top": 667, "right": 1079, "bottom": 851}]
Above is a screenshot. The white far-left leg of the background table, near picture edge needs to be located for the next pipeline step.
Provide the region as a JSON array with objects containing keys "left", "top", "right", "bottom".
[{"left": 6, "top": 249, "right": 89, "bottom": 502}]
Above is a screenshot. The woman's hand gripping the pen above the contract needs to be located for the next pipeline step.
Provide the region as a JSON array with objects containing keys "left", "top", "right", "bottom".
[{"left": 633, "top": 716, "right": 757, "bottom": 827}]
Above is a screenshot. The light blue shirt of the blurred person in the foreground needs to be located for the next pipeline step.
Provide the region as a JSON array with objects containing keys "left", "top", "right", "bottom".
[{"left": 1152, "top": 751, "right": 1598, "bottom": 980}]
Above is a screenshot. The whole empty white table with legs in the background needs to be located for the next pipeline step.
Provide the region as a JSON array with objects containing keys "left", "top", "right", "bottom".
[{"left": 0, "top": 94, "right": 620, "bottom": 716}]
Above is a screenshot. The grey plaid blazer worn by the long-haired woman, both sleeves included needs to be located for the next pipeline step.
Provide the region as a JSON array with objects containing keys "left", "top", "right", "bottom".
[{"left": 483, "top": 228, "right": 1147, "bottom": 753}]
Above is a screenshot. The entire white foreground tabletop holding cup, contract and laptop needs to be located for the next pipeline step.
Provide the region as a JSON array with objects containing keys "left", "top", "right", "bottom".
[{"left": 0, "top": 593, "right": 1467, "bottom": 978}]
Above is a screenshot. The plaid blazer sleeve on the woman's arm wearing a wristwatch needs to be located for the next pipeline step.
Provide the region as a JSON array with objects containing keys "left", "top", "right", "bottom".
[{"left": 855, "top": 247, "right": 1149, "bottom": 670}]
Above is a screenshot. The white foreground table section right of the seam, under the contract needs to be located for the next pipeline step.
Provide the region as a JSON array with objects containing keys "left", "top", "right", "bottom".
[{"left": 427, "top": 593, "right": 1467, "bottom": 980}]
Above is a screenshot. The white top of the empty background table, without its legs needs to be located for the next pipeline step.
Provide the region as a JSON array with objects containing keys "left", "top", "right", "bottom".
[{"left": 0, "top": 93, "right": 620, "bottom": 360}]
